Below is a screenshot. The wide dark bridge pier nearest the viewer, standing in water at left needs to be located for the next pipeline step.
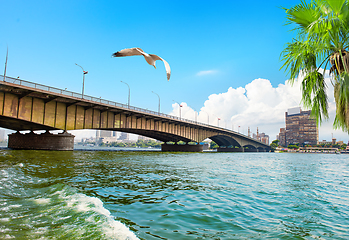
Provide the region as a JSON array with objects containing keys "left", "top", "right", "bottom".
[{"left": 8, "top": 132, "right": 75, "bottom": 151}]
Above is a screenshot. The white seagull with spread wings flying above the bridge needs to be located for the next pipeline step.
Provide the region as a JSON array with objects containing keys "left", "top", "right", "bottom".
[{"left": 112, "top": 48, "right": 171, "bottom": 81}]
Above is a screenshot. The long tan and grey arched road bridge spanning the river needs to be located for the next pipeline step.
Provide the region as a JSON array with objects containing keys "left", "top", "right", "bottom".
[{"left": 0, "top": 75, "right": 270, "bottom": 152}]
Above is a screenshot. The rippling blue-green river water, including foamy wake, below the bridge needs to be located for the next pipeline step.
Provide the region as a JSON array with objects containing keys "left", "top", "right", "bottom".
[{"left": 0, "top": 149, "right": 349, "bottom": 240}]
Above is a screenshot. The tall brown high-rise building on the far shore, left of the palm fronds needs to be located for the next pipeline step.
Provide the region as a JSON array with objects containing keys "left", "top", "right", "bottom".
[{"left": 279, "top": 107, "right": 319, "bottom": 146}]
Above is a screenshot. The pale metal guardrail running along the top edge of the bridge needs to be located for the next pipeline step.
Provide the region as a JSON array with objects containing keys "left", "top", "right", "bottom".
[{"left": 0, "top": 75, "right": 264, "bottom": 144}]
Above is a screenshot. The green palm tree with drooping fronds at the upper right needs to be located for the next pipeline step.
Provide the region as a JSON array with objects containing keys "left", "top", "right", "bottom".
[{"left": 281, "top": 0, "right": 349, "bottom": 132}]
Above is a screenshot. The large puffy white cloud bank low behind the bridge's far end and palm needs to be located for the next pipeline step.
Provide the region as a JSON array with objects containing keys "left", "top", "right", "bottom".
[{"left": 170, "top": 73, "right": 349, "bottom": 142}]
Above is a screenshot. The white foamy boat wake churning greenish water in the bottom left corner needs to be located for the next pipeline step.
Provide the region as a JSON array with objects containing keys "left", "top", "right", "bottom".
[{"left": 0, "top": 165, "right": 138, "bottom": 240}]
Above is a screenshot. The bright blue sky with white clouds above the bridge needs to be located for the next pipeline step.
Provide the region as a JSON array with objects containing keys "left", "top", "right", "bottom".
[{"left": 0, "top": 0, "right": 349, "bottom": 142}]
